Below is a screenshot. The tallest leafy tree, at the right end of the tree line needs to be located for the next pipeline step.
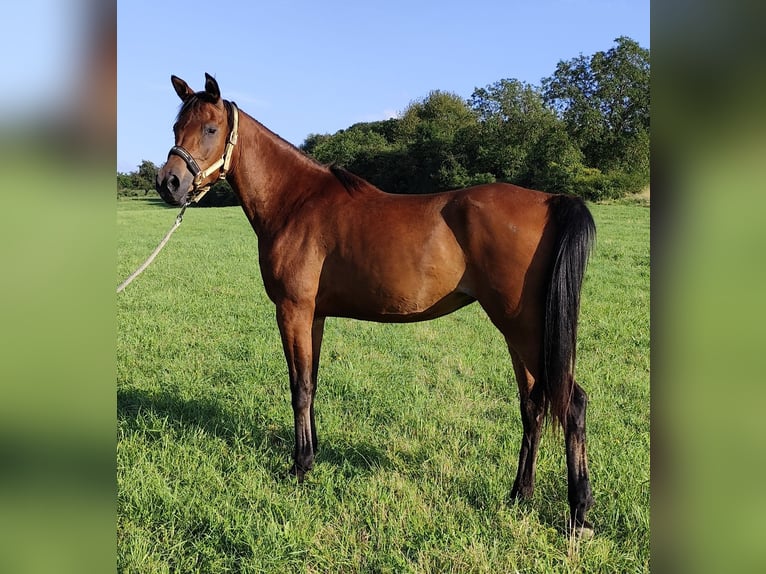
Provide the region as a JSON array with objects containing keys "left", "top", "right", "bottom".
[{"left": 543, "top": 36, "right": 650, "bottom": 178}]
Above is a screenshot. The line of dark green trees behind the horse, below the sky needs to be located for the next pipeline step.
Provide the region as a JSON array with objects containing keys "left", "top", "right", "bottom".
[{"left": 118, "top": 36, "right": 650, "bottom": 200}]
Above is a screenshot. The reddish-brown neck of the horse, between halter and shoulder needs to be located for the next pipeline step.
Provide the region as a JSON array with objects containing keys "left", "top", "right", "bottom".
[{"left": 227, "top": 112, "right": 326, "bottom": 238}]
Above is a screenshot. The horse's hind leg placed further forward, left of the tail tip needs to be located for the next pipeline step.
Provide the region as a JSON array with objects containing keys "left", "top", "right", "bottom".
[{"left": 509, "top": 346, "right": 545, "bottom": 500}]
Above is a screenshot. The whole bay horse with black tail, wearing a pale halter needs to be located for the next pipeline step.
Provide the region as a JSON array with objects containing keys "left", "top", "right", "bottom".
[{"left": 157, "top": 74, "right": 595, "bottom": 534}]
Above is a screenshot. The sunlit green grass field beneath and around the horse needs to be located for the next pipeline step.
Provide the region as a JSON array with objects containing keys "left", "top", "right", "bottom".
[{"left": 115, "top": 199, "right": 650, "bottom": 573}]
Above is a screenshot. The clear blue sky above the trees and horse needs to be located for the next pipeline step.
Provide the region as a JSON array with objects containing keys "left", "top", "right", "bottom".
[{"left": 117, "top": 0, "right": 651, "bottom": 171}]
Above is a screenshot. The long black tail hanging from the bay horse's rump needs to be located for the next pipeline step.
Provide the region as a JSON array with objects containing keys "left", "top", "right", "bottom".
[{"left": 543, "top": 195, "right": 596, "bottom": 429}]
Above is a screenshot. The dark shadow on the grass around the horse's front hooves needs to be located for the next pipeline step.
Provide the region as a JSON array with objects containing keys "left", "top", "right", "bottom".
[{"left": 117, "top": 389, "right": 391, "bottom": 480}]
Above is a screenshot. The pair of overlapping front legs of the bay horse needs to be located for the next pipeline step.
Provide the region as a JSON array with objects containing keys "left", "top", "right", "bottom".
[{"left": 277, "top": 303, "right": 318, "bottom": 481}]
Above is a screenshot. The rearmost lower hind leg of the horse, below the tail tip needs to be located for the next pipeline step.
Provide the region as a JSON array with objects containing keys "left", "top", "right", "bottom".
[{"left": 566, "top": 382, "right": 593, "bottom": 535}]
